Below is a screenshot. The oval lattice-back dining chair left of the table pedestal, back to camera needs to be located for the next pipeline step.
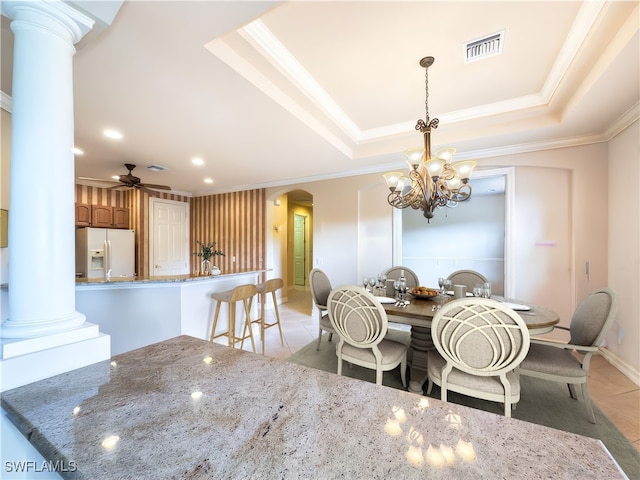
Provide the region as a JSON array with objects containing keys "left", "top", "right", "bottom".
[{"left": 327, "top": 286, "right": 409, "bottom": 387}]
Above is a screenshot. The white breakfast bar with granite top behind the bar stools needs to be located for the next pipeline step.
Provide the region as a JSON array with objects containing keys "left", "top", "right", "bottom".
[{"left": 76, "top": 269, "right": 267, "bottom": 355}]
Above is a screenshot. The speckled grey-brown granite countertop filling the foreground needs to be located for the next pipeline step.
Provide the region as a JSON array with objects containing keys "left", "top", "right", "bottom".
[{"left": 2, "top": 336, "right": 624, "bottom": 480}]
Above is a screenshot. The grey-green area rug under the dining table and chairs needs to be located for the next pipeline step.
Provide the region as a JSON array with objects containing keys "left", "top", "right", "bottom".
[{"left": 287, "top": 330, "right": 640, "bottom": 480}]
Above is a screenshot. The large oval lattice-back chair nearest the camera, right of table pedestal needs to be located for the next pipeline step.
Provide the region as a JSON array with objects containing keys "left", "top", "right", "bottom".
[{"left": 427, "top": 297, "right": 530, "bottom": 417}]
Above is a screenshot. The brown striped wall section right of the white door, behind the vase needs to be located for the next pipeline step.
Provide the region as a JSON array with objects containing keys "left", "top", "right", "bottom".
[{"left": 191, "top": 189, "right": 266, "bottom": 272}]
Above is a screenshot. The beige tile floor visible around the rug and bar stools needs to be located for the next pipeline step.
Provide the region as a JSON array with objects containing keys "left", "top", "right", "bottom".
[{"left": 216, "top": 287, "right": 640, "bottom": 451}]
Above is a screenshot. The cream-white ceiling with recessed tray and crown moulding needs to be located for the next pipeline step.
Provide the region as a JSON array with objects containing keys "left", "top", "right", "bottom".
[{"left": 0, "top": 0, "right": 640, "bottom": 195}]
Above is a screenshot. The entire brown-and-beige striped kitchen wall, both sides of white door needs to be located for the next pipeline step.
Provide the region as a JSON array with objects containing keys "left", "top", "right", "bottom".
[{"left": 76, "top": 185, "right": 266, "bottom": 277}]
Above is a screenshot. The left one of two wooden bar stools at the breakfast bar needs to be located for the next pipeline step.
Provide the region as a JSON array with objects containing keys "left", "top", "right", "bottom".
[{"left": 209, "top": 284, "right": 264, "bottom": 353}]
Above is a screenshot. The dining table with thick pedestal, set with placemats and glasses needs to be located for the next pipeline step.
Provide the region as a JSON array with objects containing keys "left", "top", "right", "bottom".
[{"left": 374, "top": 292, "right": 560, "bottom": 394}]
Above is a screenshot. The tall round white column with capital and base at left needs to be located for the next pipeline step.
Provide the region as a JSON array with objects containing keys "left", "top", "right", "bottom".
[{"left": 0, "top": 0, "right": 94, "bottom": 339}]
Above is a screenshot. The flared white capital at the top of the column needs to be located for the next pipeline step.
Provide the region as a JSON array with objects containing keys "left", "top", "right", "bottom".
[{"left": 2, "top": 0, "right": 95, "bottom": 45}]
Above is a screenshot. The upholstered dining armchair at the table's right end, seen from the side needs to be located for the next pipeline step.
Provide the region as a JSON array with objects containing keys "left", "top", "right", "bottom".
[{"left": 518, "top": 288, "right": 618, "bottom": 423}]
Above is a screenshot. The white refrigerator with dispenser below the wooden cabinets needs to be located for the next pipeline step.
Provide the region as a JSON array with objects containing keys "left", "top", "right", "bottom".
[{"left": 76, "top": 227, "right": 135, "bottom": 279}]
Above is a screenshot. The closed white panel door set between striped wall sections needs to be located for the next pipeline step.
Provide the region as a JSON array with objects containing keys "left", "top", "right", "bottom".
[{"left": 149, "top": 198, "right": 189, "bottom": 275}]
